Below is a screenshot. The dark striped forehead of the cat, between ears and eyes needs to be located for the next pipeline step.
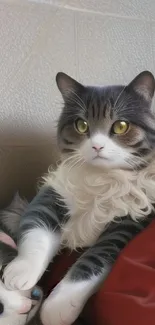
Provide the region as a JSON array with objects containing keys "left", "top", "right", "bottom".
[{"left": 80, "top": 86, "right": 145, "bottom": 122}]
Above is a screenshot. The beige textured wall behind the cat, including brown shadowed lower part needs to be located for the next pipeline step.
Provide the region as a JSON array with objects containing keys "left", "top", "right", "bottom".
[{"left": 0, "top": 0, "right": 155, "bottom": 204}]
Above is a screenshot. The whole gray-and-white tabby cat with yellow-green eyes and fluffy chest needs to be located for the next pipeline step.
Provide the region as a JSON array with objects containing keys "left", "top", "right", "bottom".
[{"left": 4, "top": 71, "right": 155, "bottom": 325}]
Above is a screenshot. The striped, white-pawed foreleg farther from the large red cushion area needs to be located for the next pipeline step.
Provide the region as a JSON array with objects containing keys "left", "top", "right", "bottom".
[{"left": 4, "top": 187, "right": 66, "bottom": 290}]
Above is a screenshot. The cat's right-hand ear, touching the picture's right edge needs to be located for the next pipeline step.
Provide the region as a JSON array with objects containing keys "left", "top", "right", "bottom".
[{"left": 128, "top": 71, "right": 155, "bottom": 102}]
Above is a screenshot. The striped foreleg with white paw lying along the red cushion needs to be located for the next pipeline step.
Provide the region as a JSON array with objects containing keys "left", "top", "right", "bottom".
[{"left": 41, "top": 219, "right": 149, "bottom": 325}]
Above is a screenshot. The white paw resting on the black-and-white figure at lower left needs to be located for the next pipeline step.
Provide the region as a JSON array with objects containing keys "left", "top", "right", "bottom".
[{"left": 3, "top": 257, "right": 40, "bottom": 290}]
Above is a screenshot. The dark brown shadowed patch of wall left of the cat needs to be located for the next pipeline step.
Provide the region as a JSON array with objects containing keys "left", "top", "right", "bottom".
[{"left": 0, "top": 130, "right": 59, "bottom": 208}]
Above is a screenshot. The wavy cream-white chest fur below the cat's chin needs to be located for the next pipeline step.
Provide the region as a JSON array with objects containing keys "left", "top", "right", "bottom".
[{"left": 45, "top": 159, "right": 155, "bottom": 249}]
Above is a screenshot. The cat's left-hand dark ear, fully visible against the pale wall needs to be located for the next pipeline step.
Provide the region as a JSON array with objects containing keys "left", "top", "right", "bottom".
[{"left": 56, "top": 72, "right": 84, "bottom": 100}]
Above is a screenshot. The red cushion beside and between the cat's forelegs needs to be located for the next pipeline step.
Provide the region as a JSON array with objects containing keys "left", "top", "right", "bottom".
[{"left": 45, "top": 222, "right": 155, "bottom": 325}]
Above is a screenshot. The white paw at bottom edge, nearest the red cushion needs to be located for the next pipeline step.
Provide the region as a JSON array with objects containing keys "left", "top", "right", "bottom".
[{"left": 41, "top": 284, "right": 83, "bottom": 325}]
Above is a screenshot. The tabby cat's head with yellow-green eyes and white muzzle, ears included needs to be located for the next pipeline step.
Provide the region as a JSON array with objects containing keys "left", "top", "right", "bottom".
[{"left": 56, "top": 71, "right": 155, "bottom": 169}]
